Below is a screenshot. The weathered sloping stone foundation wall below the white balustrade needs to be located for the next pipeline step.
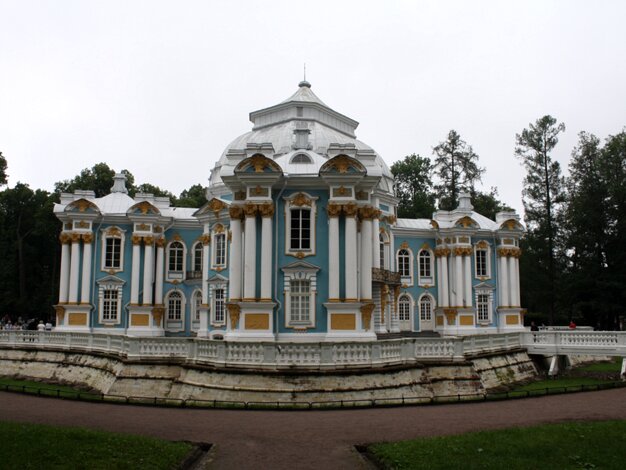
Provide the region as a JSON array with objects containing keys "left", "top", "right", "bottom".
[{"left": 0, "top": 349, "right": 536, "bottom": 402}]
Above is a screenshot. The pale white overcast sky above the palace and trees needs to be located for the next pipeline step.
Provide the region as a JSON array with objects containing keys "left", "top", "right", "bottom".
[{"left": 0, "top": 0, "right": 626, "bottom": 211}]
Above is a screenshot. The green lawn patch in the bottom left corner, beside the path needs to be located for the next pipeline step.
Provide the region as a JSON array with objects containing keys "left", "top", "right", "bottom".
[{"left": 0, "top": 421, "right": 192, "bottom": 470}]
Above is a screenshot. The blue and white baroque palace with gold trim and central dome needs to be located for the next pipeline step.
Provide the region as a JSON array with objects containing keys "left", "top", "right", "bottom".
[{"left": 54, "top": 81, "right": 523, "bottom": 341}]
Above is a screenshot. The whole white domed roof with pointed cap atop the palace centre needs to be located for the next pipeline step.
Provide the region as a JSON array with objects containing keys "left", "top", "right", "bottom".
[{"left": 209, "top": 81, "right": 393, "bottom": 192}]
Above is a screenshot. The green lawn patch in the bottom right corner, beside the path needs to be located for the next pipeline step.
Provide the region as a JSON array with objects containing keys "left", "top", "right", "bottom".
[{"left": 368, "top": 421, "right": 626, "bottom": 470}]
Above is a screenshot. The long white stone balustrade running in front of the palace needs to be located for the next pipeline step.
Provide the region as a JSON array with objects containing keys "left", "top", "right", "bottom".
[{"left": 0, "top": 331, "right": 626, "bottom": 369}]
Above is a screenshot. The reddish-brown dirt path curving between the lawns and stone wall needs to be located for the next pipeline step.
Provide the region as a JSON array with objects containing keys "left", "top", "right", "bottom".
[{"left": 0, "top": 388, "right": 626, "bottom": 469}]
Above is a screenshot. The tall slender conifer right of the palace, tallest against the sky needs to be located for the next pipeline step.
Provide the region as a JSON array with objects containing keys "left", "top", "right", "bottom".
[{"left": 515, "top": 116, "right": 565, "bottom": 324}]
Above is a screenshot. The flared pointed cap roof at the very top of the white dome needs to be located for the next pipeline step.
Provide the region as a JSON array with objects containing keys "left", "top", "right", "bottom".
[{"left": 250, "top": 81, "right": 359, "bottom": 138}]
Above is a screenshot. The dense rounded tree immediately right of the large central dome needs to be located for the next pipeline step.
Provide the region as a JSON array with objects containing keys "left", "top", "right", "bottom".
[{"left": 391, "top": 153, "right": 435, "bottom": 219}]
